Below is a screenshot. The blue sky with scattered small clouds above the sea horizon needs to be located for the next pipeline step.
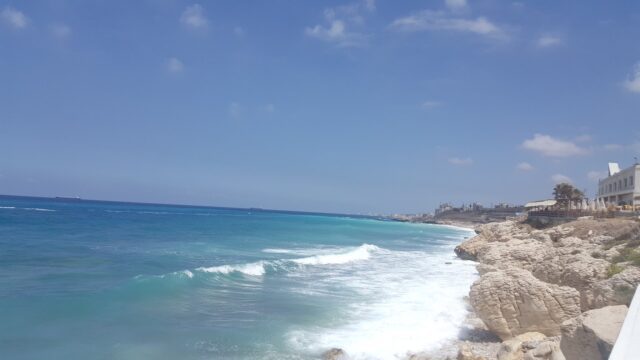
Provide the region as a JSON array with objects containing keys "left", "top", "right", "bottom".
[{"left": 0, "top": 0, "right": 640, "bottom": 214}]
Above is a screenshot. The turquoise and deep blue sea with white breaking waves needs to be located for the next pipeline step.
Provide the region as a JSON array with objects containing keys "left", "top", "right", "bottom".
[{"left": 0, "top": 197, "right": 476, "bottom": 359}]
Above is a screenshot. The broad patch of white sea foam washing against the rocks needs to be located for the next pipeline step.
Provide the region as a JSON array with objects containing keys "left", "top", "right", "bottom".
[{"left": 286, "top": 249, "right": 476, "bottom": 360}]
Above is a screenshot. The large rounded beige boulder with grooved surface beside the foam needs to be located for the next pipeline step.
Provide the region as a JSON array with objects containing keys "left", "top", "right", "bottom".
[{"left": 469, "top": 268, "right": 580, "bottom": 340}]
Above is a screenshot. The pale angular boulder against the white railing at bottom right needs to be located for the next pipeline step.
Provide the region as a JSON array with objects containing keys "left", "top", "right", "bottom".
[{"left": 560, "top": 305, "right": 628, "bottom": 360}]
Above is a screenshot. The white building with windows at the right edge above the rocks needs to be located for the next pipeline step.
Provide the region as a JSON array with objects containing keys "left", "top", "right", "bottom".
[{"left": 598, "top": 163, "right": 640, "bottom": 206}]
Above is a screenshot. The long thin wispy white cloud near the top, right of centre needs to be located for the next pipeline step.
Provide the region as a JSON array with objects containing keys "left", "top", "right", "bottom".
[{"left": 389, "top": 10, "right": 508, "bottom": 39}]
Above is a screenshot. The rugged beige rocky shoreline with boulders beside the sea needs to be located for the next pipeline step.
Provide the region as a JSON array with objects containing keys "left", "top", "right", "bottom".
[{"left": 444, "top": 219, "right": 640, "bottom": 360}]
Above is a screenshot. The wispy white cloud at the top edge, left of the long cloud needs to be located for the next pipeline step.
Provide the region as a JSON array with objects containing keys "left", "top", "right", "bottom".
[{"left": 304, "top": 0, "right": 376, "bottom": 47}]
